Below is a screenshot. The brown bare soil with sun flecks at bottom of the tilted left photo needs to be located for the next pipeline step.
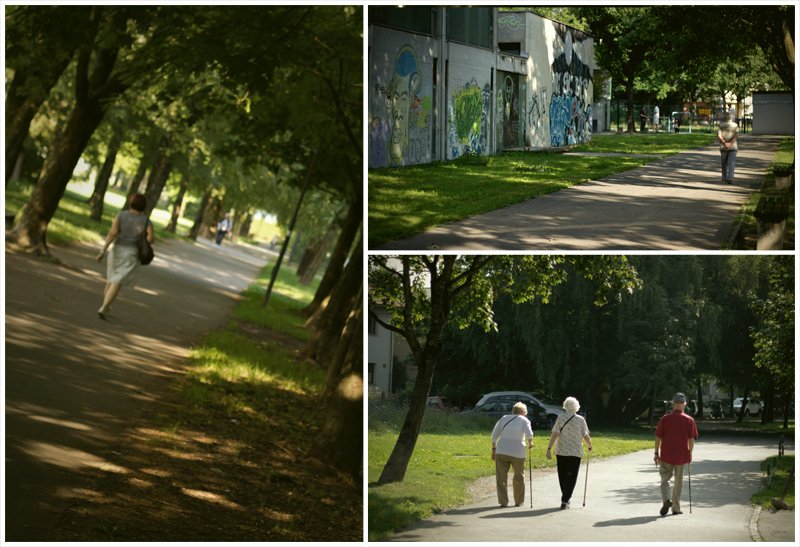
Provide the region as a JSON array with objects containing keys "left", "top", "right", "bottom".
[{"left": 46, "top": 324, "right": 363, "bottom": 542}]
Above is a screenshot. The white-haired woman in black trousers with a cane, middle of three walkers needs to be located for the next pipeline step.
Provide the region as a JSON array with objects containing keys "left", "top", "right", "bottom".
[{"left": 546, "top": 397, "right": 592, "bottom": 509}]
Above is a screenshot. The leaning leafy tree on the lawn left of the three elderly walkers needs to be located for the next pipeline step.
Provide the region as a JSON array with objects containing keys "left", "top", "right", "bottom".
[{"left": 368, "top": 255, "right": 640, "bottom": 484}]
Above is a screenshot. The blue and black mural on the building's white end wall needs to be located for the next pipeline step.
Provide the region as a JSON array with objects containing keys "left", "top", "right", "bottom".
[{"left": 550, "top": 25, "right": 592, "bottom": 146}]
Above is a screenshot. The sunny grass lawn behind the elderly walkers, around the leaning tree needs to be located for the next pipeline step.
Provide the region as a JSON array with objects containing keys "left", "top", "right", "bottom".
[{"left": 367, "top": 403, "right": 653, "bottom": 541}]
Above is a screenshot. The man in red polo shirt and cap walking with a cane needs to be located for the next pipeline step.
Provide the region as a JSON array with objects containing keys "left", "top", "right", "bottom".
[{"left": 653, "top": 393, "right": 697, "bottom": 516}]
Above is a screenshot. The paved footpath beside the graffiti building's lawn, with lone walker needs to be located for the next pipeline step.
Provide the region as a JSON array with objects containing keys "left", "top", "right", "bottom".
[{"left": 378, "top": 135, "right": 781, "bottom": 251}]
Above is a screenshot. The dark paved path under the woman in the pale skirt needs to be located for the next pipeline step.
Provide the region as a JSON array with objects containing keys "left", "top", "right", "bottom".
[{"left": 3, "top": 240, "right": 267, "bottom": 542}]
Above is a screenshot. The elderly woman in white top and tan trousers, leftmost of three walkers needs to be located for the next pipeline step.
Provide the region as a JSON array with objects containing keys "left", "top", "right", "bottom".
[{"left": 492, "top": 403, "right": 533, "bottom": 507}]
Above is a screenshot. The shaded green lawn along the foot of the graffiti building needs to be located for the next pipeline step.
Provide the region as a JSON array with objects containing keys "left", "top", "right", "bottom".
[{"left": 368, "top": 134, "right": 715, "bottom": 247}]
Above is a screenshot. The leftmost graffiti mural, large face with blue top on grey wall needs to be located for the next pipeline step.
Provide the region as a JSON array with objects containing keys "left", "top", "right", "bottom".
[{"left": 369, "top": 44, "right": 432, "bottom": 167}]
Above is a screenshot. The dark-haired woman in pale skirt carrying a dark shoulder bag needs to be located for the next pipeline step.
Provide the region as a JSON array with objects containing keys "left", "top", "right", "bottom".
[{"left": 97, "top": 194, "right": 155, "bottom": 319}]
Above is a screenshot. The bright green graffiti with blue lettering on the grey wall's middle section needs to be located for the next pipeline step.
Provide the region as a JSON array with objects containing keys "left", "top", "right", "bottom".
[{"left": 448, "top": 78, "right": 492, "bottom": 158}]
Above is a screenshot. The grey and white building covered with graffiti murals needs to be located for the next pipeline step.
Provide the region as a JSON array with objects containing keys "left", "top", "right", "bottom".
[{"left": 367, "top": 6, "right": 594, "bottom": 168}]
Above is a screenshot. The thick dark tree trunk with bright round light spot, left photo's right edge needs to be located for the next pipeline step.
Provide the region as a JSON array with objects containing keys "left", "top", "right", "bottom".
[{"left": 306, "top": 298, "right": 364, "bottom": 482}]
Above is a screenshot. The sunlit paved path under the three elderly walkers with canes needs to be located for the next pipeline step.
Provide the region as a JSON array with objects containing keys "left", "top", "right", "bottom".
[{"left": 388, "top": 425, "right": 796, "bottom": 545}]
